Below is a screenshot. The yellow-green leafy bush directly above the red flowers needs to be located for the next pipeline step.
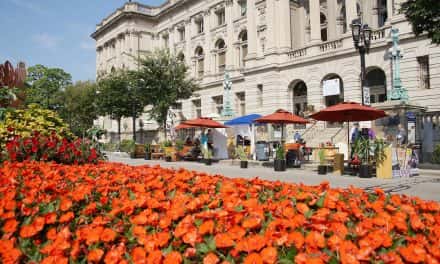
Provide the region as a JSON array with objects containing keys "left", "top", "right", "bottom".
[{"left": 0, "top": 105, "right": 73, "bottom": 145}]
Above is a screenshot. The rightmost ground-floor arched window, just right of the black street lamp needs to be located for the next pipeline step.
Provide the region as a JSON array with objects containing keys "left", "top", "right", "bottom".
[{"left": 365, "top": 67, "right": 387, "bottom": 103}]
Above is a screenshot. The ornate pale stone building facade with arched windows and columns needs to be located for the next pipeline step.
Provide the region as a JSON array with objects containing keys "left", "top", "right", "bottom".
[{"left": 92, "top": 0, "right": 440, "bottom": 158}]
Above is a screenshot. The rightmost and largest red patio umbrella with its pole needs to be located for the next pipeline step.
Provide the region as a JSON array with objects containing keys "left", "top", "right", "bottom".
[{"left": 310, "top": 102, "right": 387, "bottom": 153}]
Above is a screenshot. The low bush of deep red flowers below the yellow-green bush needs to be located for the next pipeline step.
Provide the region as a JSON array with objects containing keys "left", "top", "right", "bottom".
[{"left": 2, "top": 133, "right": 104, "bottom": 164}]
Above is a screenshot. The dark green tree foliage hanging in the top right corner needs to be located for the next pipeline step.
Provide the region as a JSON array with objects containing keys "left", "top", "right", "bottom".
[{"left": 400, "top": 0, "right": 440, "bottom": 44}]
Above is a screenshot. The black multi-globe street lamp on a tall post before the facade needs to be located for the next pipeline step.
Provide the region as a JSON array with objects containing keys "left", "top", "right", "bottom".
[{"left": 351, "top": 18, "right": 371, "bottom": 105}]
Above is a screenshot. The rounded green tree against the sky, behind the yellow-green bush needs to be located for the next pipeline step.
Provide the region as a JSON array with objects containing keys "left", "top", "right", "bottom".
[{"left": 26, "top": 64, "right": 72, "bottom": 109}]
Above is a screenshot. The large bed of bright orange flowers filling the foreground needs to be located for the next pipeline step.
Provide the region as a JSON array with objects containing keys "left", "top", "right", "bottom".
[{"left": 0, "top": 162, "right": 440, "bottom": 264}]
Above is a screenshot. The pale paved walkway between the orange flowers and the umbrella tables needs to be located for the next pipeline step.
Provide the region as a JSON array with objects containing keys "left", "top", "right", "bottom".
[{"left": 109, "top": 155, "right": 440, "bottom": 201}]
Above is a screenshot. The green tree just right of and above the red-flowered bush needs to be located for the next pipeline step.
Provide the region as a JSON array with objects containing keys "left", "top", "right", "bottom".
[{"left": 57, "top": 81, "right": 98, "bottom": 136}]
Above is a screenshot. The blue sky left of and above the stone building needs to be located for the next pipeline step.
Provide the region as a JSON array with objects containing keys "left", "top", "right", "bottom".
[{"left": 0, "top": 0, "right": 164, "bottom": 81}]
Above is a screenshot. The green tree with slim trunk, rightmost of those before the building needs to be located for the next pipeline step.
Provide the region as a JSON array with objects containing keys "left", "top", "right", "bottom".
[{"left": 136, "top": 50, "right": 197, "bottom": 138}]
